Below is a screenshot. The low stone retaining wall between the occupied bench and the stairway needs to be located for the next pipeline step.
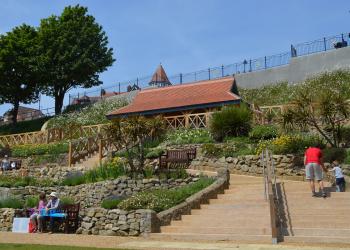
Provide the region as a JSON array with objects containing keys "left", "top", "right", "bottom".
[{"left": 77, "top": 208, "right": 156, "bottom": 236}]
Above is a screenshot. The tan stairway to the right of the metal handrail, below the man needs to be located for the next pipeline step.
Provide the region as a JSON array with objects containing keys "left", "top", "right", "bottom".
[{"left": 280, "top": 181, "right": 350, "bottom": 243}]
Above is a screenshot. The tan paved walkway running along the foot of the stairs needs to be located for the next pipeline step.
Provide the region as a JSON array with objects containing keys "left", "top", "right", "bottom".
[{"left": 0, "top": 232, "right": 350, "bottom": 250}]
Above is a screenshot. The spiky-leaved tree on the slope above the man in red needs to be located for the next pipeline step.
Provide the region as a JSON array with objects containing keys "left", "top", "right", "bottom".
[{"left": 283, "top": 71, "right": 350, "bottom": 147}]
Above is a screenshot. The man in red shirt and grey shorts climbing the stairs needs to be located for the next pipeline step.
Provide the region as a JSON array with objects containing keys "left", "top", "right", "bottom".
[{"left": 304, "top": 145, "right": 327, "bottom": 198}]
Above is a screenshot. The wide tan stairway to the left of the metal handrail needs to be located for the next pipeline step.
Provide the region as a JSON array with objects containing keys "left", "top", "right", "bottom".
[{"left": 153, "top": 175, "right": 271, "bottom": 243}]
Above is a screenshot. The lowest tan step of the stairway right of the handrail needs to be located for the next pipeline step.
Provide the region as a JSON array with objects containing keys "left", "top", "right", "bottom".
[{"left": 284, "top": 236, "right": 350, "bottom": 244}]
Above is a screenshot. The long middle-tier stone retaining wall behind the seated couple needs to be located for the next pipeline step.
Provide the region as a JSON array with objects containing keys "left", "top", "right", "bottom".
[{"left": 0, "top": 176, "right": 199, "bottom": 208}]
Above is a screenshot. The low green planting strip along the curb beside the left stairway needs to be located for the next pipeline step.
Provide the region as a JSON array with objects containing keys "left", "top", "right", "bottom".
[{"left": 118, "top": 178, "right": 214, "bottom": 212}]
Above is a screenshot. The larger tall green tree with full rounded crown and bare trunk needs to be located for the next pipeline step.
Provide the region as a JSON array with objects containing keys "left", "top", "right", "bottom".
[{"left": 39, "top": 5, "right": 114, "bottom": 114}]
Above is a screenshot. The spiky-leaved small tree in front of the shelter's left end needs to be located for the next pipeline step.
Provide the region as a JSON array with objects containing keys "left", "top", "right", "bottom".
[{"left": 106, "top": 116, "right": 165, "bottom": 172}]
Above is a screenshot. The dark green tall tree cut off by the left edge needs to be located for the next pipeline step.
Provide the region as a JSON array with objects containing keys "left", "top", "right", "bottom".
[{"left": 0, "top": 24, "right": 39, "bottom": 123}]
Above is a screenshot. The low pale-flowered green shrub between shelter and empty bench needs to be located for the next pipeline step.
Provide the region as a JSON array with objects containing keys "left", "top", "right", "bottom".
[{"left": 165, "top": 129, "right": 214, "bottom": 145}]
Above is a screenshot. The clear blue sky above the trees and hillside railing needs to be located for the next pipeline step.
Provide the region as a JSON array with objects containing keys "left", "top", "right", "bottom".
[{"left": 0, "top": 0, "right": 350, "bottom": 114}]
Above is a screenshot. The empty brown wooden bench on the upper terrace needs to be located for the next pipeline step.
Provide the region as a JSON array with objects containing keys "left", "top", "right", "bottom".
[{"left": 159, "top": 148, "right": 196, "bottom": 169}]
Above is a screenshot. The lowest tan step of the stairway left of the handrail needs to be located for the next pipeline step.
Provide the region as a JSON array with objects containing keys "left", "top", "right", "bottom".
[{"left": 150, "top": 233, "right": 271, "bottom": 243}]
